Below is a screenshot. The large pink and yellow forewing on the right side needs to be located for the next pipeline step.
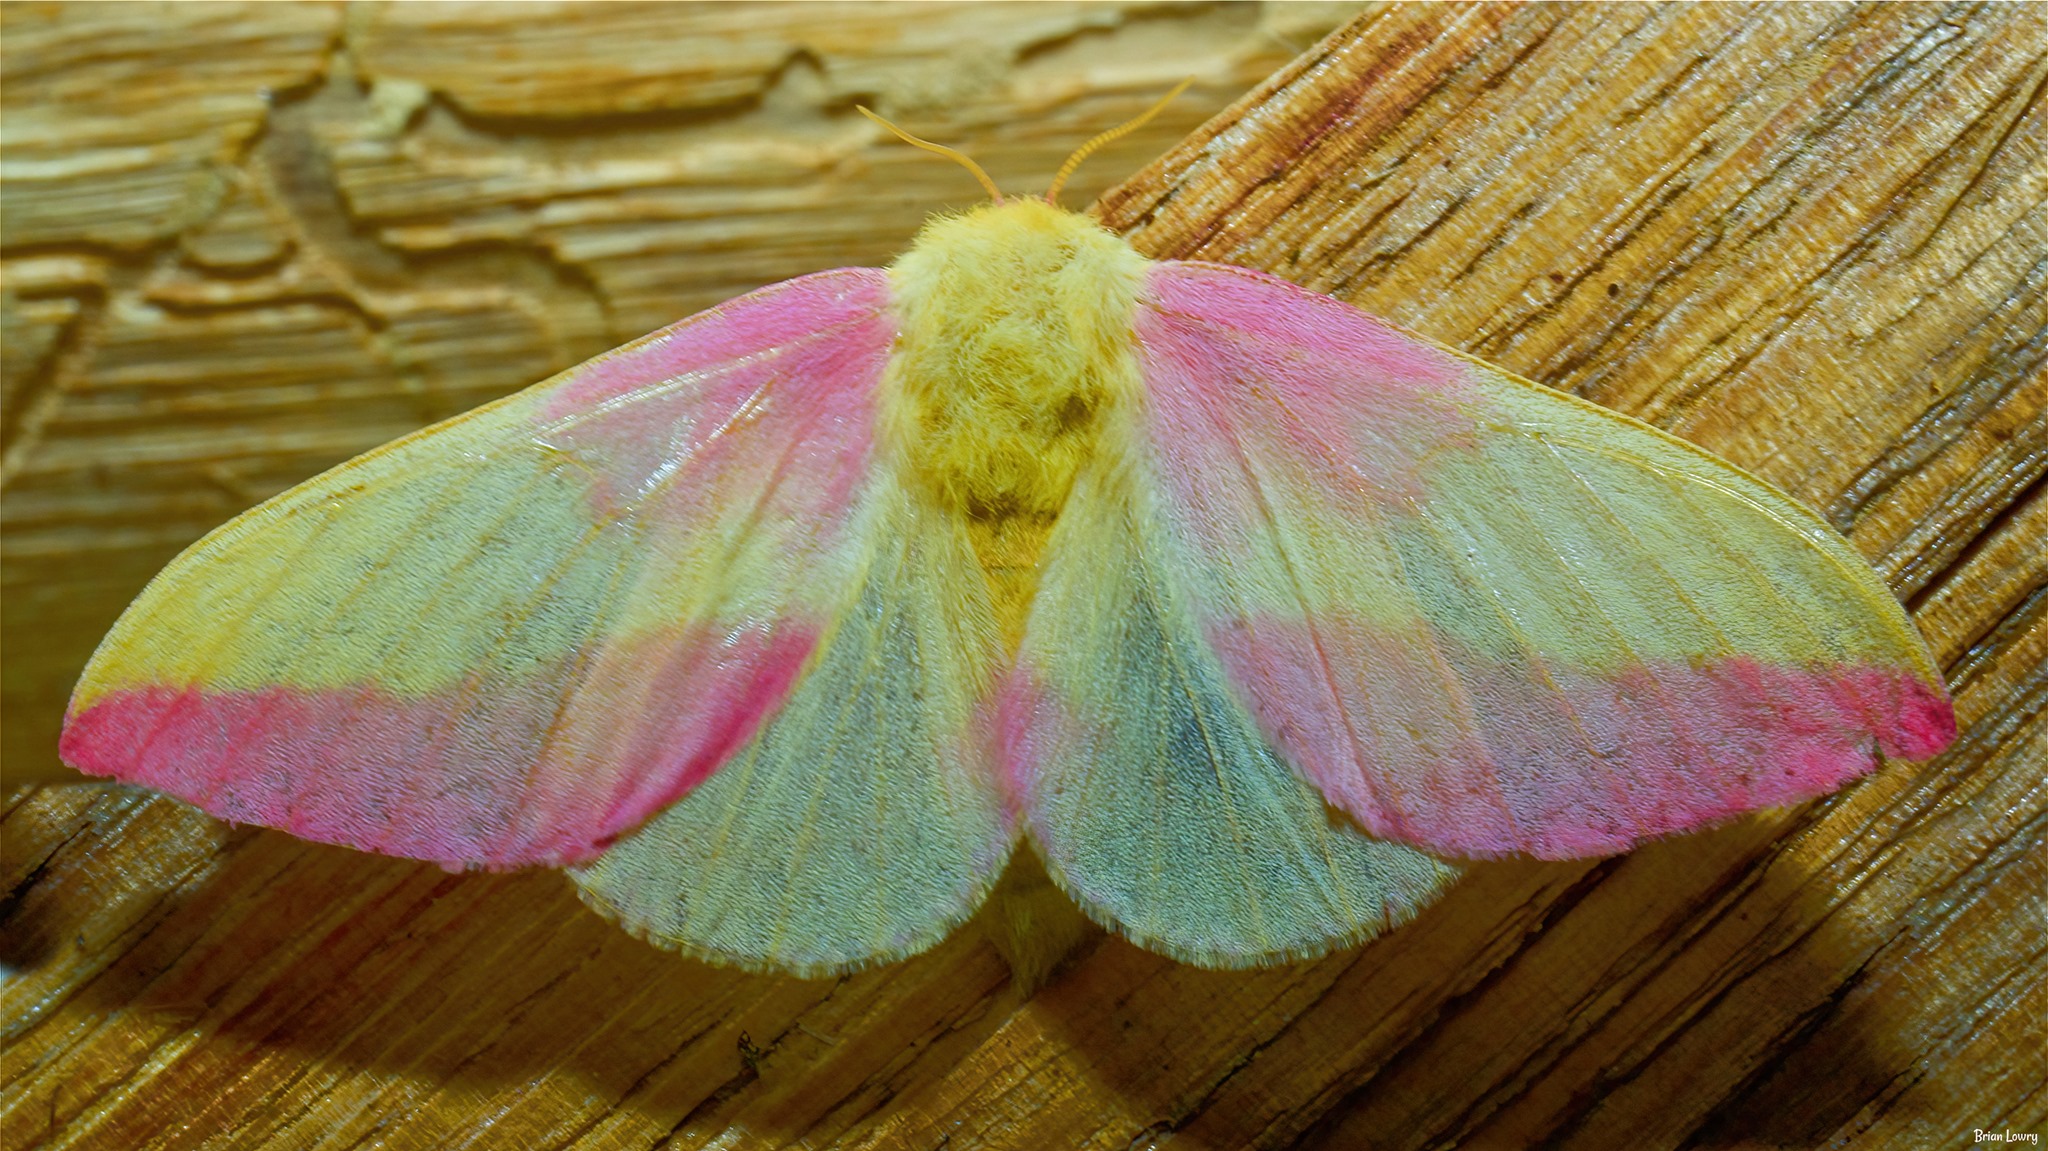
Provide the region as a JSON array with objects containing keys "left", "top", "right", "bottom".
[{"left": 1118, "top": 264, "right": 1956, "bottom": 858}]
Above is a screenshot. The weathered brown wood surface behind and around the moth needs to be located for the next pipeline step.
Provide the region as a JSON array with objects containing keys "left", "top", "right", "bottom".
[{"left": 0, "top": 4, "right": 2048, "bottom": 1149}]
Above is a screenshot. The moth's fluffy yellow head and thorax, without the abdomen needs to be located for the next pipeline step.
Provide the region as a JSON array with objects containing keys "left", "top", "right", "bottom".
[{"left": 881, "top": 201, "right": 1145, "bottom": 518}]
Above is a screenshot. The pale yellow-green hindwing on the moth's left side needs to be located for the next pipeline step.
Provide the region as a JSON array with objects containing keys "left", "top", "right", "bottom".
[{"left": 573, "top": 469, "right": 1016, "bottom": 975}]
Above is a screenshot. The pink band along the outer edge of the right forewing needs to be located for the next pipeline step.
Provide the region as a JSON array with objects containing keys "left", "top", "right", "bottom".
[{"left": 1210, "top": 619, "right": 1956, "bottom": 858}]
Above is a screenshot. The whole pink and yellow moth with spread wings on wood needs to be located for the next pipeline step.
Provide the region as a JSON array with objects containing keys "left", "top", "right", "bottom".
[{"left": 61, "top": 102, "right": 1956, "bottom": 973}]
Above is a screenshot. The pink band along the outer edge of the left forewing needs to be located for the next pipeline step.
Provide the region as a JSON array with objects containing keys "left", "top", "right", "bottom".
[{"left": 63, "top": 627, "right": 817, "bottom": 868}]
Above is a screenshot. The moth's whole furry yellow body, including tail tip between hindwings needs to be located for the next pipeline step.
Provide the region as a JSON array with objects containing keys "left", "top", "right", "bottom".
[{"left": 879, "top": 199, "right": 1145, "bottom": 970}]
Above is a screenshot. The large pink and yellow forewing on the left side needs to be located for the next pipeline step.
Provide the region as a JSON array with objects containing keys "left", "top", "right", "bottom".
[{"left": 61, "top": 268, "right": 909, "bottom": 866}]
